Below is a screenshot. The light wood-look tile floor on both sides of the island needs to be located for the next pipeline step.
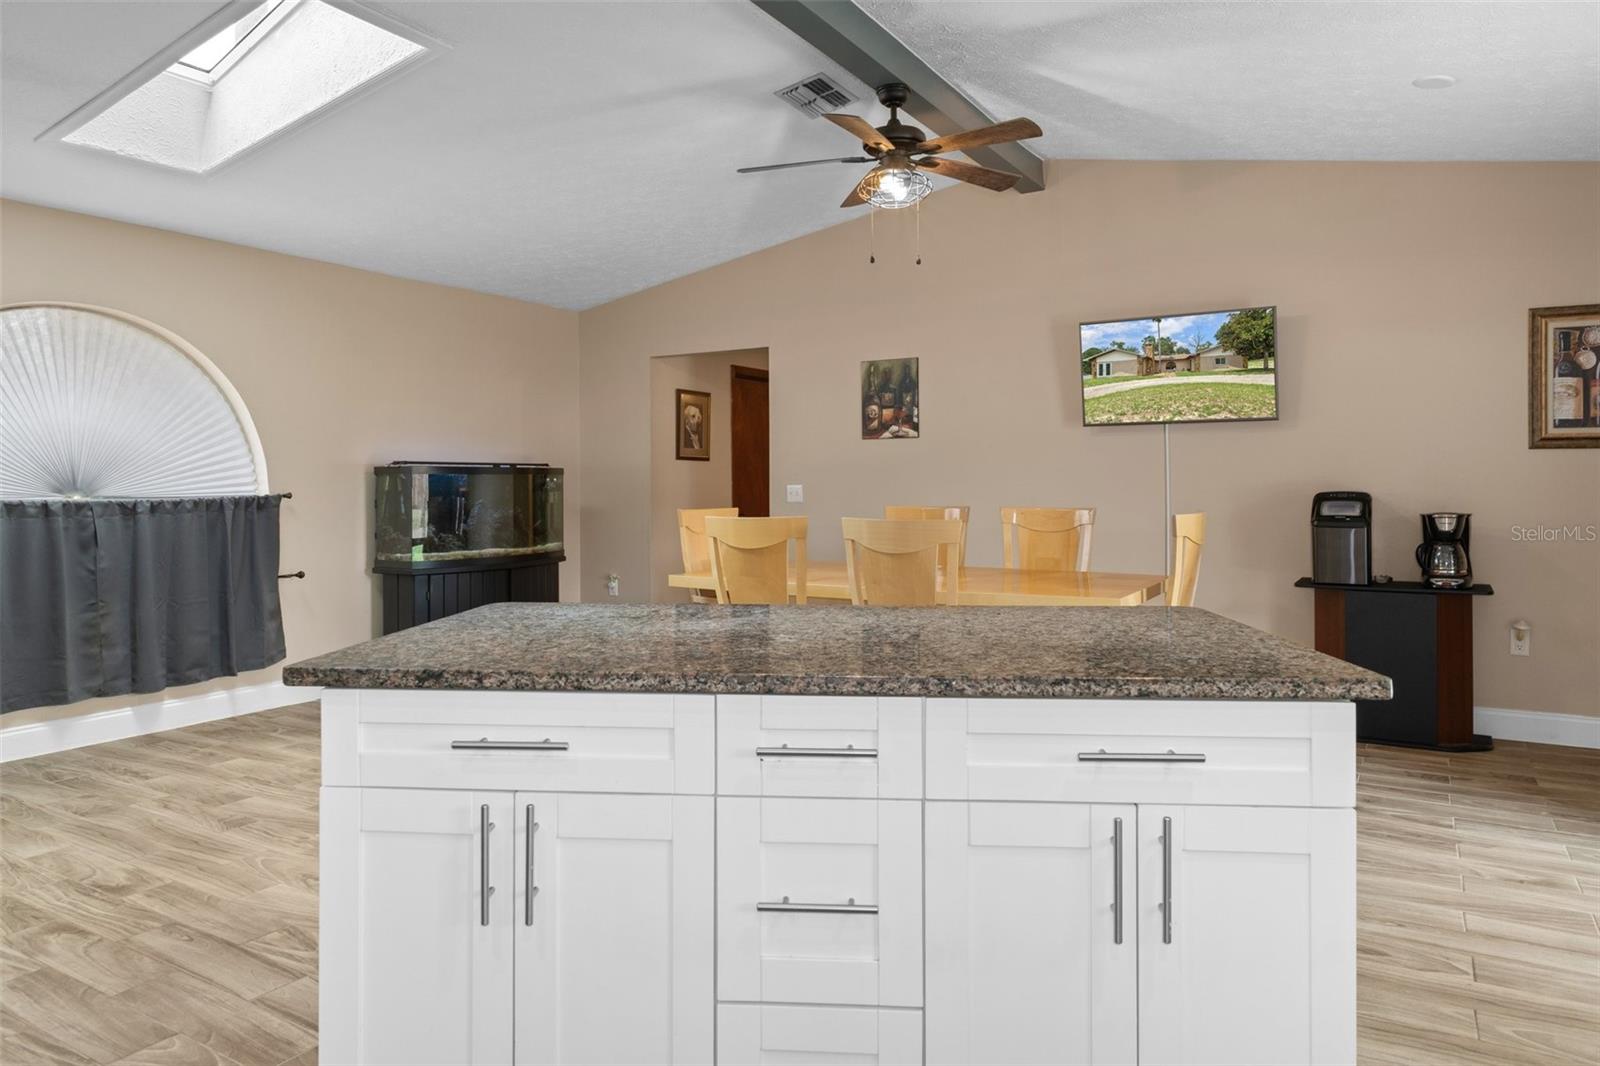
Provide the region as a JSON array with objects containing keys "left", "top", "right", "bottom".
[{"left": 0, "top": 704, "right": 1600, "bottom": 1066}]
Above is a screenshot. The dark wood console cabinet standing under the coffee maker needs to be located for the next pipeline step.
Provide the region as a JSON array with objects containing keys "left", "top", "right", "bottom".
[{"left": 1294, "top": 578, "right": 1494, "bottom": 751}]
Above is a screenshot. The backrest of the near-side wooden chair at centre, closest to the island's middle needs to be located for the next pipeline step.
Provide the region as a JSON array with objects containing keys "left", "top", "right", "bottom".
[{"left": 845, "top": 519, "right": 962, "bottom": 607}]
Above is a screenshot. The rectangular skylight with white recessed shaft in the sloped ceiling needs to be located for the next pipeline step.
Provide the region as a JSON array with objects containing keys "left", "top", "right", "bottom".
[{"left": 61, "top": 0, "right": 429, "bottom": 174}]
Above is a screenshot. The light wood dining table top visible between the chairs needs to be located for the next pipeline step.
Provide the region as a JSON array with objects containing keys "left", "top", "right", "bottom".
[{"left": 667, "top": 560, "right": 1166, "bottom": 607}]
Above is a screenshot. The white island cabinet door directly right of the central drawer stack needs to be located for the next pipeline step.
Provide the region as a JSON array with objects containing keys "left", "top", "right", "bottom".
[{"left": 926, "top": 802, "right": 1139, "bottom": 1064}]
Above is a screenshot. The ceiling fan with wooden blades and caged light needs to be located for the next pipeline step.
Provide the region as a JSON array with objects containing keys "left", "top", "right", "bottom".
[{"left": 739, "top": 82, "right": 1043, "bottom": 208}]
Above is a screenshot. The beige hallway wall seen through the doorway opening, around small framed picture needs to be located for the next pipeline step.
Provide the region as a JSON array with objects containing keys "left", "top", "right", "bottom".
[{"left": 652, "top": 349, "right": 766, "bottom": 603}]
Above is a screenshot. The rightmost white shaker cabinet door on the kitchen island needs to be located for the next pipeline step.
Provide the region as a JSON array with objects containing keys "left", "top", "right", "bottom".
[{"left": 1139, "top": 805, "right": 1355, "bottom": 1066}]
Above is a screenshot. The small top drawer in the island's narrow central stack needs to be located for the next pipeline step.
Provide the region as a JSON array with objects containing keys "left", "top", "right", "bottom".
[{"left": 717, "top": 696, "right": 922, "bottom": 799}]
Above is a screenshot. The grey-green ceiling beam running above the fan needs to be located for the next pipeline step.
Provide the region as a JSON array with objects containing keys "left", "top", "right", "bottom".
[{"left": 752, "top": 0, "right": 1045, "bottom": 192}]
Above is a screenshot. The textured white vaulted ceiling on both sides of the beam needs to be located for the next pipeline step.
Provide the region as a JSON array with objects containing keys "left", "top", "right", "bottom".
[{"left": 0, "top": 0, "right": 1600, "bottom": 307}]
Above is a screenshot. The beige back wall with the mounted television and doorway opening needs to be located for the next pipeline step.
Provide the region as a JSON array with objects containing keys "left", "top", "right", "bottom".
[{"left": 581, "top": 163, "right": 1600, "bottom": 714}]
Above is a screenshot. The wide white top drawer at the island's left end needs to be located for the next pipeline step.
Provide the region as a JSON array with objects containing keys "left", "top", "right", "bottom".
[{"left": 322, "top": 690, "right": 715, "bottom": 795}]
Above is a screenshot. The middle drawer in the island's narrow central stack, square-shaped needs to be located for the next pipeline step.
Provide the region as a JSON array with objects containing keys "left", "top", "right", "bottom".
[{"left": 717, "top": 799, "right": 922, "bottom": 1007}]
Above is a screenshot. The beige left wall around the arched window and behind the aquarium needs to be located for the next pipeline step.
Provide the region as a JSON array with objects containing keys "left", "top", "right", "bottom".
[{"left": 0, "top": 200, "right": 581, "bottom": 727}]
